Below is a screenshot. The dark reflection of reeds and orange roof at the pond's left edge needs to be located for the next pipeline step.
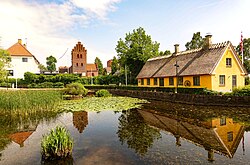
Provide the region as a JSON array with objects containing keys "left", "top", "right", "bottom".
[{"left": 0, "top": 109, "right": 59, "bottom": 151}]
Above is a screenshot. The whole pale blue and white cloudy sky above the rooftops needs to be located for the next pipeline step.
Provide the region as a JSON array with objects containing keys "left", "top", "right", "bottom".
[{"left": 0, "top": 0, "right": 250, "bottom": 67}]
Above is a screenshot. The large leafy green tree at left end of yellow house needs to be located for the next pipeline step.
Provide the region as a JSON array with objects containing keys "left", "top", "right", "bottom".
[{"left": 116, "top": 27, "right": 160, "bottom": 84}]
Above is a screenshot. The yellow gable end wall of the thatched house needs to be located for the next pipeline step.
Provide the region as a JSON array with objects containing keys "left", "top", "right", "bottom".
[{"left": 212, "top": 49, "right": 245, "bottom": 92}]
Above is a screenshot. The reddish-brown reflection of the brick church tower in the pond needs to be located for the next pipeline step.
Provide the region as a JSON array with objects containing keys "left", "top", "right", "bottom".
[{"left": 73, "top": 111, "right": 88, "bottom": 133}]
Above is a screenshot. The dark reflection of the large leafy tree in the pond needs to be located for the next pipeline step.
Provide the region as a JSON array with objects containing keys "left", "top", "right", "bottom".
[{"left": 117, "top": 110, "right": 161, "bottom": 155}]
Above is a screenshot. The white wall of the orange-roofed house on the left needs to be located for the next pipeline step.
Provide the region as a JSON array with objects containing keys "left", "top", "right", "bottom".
[{"left": 7, "top": 56, "right": 40, "bottom": 78}]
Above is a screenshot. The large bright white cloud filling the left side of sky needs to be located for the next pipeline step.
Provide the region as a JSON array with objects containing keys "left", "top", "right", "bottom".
[{"left": 0, "top": 0, "right": 120, "bottom": 66}]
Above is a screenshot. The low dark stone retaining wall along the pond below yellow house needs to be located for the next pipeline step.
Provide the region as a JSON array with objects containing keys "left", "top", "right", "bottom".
[{"left": 109, "top": 89, "right": 250, "bottom": 107}]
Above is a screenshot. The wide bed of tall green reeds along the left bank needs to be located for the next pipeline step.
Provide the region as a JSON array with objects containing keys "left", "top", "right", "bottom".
[{"left": 0, "top": 90, "right": 62, "bottom": 110}]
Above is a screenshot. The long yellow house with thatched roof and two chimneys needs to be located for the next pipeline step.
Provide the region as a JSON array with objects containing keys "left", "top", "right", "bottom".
[{"left": 137, "top": 35, "right": 247, "bottom": 92}]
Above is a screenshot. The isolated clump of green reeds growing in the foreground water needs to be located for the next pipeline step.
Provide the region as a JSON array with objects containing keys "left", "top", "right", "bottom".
[{"left": 41, "top": 126, "right": 73, "bottom": 160}]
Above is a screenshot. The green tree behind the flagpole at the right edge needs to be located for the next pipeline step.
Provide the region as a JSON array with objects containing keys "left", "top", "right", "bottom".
[{"left": 236, "top": 38, "right": 250, "bottom": 73}]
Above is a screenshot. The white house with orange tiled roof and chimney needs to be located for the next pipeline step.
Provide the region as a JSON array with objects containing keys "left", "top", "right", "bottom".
[{"left": 7, "top": 39, "right": 40, "bottom": 78}]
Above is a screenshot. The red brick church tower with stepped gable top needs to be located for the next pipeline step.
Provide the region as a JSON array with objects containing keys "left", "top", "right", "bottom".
[{"left": 70, "top": 42, "right": 87, "bottom": 76}]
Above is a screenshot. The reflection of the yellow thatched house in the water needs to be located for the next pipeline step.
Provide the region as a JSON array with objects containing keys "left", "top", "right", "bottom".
[{"left": 138, "top": 110, "right": 244, "bottom": 161}]
